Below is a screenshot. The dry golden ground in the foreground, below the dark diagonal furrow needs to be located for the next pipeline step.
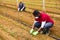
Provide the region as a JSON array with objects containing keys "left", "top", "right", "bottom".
[{"left": 0, "top": 15, "right": 54, "bottom": 40}]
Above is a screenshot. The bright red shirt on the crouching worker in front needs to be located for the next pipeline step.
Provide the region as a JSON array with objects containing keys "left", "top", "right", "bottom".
[{"left": 35, "top": 12, "right": 54, "bottom": 24}]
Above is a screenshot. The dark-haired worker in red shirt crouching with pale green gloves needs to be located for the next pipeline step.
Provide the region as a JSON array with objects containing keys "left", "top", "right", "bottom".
[{"left": 30, "top": 10, "right": 54, "bottom": 35}]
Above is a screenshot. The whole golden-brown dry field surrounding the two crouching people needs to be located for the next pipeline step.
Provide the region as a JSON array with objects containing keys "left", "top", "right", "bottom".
[{"left": 0, "top": 0, "right": 60, "bottom": 40}]
